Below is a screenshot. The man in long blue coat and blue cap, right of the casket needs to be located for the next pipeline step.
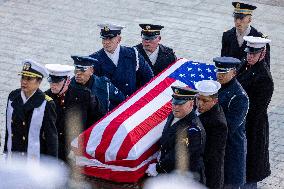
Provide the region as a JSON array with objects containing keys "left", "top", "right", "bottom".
[{"left": 213, "top": 57, "right": 249, "bottom": 189}]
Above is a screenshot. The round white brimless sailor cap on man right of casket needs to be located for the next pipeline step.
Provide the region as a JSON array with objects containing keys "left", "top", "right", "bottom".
[{"left": 195, "top": 80, "right": 221, "bottom": 96}]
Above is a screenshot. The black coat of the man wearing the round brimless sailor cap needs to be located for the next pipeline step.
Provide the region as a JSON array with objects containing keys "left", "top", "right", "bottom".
[{"left": 199, "top": 104, "right": 228, "bottom": 189}]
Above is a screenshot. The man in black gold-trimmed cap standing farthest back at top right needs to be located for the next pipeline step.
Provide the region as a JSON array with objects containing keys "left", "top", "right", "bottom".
[{"left": 221, "top": 2, "right": 270, "bottom": 67}]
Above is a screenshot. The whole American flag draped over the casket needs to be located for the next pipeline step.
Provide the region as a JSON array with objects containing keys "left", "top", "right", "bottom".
[{"left": 72, "top": 59, "right": 216, "bottom": 182}]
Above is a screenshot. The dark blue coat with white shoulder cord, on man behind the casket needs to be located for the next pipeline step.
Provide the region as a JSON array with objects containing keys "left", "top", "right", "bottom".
[{"left": 90, "top": 46, "right": 154, "bottom": 96}]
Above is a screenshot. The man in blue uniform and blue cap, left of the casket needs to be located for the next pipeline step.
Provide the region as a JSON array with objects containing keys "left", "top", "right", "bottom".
[{"left": 71, "top": 56, "right": 125, "bottom": 113}]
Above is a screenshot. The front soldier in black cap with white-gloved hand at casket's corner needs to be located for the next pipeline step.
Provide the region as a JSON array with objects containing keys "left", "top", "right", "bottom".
[{"left": 146, "top": 86, "right": 206, "bottom": 183}]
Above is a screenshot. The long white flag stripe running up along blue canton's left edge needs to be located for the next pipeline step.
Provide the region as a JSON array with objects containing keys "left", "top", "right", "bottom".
[{"left": 86, "top": 59, "right": 187, "bottom": 156}]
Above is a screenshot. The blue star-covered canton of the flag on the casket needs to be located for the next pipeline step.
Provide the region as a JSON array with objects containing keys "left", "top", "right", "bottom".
[{"left": 169, "top": 61, "right": 217, "bottom": 89}]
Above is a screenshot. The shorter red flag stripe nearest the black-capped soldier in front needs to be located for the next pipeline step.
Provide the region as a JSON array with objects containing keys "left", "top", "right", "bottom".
[{"left": 116, "top": 102, "right": 172, "bottom": 159}]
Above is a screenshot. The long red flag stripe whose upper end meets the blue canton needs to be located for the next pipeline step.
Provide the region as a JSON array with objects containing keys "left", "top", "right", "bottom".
[{"left": 94, "top": 77, "right": 175, "bottom": 162}]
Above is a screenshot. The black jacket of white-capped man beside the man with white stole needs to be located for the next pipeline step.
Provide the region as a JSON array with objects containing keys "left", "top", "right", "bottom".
[{"left": 46, "top": 85, "right": 103, "bottom": 160}]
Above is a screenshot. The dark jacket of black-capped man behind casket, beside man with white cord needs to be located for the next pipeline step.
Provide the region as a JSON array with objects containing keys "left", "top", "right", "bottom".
[{"left": 135, "top": 43, "right": 177, "bottom": 76}]
